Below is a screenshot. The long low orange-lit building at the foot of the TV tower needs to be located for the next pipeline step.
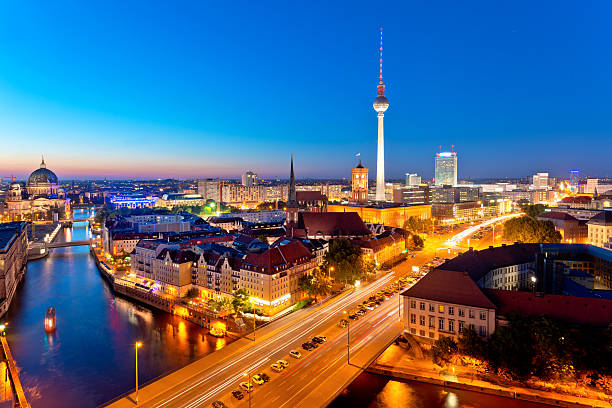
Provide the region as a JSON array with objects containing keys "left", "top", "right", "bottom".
[{"left": 327, "top": 203, "right": 431, "bottom": 228}]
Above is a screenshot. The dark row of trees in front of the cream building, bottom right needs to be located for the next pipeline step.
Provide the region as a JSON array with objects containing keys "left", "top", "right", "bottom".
[{"left": 431, "top": 315, "right": 612, "bottom": 381}]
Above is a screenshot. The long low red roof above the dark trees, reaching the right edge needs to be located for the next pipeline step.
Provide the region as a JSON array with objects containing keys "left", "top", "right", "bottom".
[{"left": 484, "top": 289, "right": 612, "bottom": 326}]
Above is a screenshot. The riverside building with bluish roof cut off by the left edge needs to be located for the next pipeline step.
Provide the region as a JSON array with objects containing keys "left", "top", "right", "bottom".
[{"left": 0, "top": 221, "right": 28, "bottom": 316}]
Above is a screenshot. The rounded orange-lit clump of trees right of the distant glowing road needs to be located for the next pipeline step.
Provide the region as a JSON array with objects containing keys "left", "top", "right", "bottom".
[{"left": 503, "top": 215, "right": 562, "bottom": 243}]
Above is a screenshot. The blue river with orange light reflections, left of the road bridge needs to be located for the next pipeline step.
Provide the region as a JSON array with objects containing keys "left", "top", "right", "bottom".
[{"left": 5, "top": 213, "right": 225, "bottom": 407}]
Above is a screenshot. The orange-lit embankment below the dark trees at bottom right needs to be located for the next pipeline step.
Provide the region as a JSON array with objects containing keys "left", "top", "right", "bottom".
[{"left": 366, "top": 341, "right": 609, "bottom": 408}]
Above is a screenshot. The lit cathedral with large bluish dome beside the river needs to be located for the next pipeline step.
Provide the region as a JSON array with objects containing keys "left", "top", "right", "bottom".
[{"left": 6, "top": 158, "right": 70, "bottom": 221}]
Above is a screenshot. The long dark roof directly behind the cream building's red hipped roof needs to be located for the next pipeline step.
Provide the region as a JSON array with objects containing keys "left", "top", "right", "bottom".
[{"left": 440, "top": 244, "right": 540, "bottom": 282}]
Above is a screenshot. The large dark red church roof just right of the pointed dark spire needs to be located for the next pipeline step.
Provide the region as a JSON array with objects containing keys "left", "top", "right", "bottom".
[{"left": 297, "top": 212, "right": 371, "bottom": 237}]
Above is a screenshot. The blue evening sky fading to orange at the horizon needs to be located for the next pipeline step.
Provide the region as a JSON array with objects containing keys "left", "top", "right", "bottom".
[{"left": 0, "top": 0, "right": 612, "bottom": 179}]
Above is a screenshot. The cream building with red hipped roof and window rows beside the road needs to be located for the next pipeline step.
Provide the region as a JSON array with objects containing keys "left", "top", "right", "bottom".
[{"left": 401, "top": 269, "right": 496, "bottom": 341}]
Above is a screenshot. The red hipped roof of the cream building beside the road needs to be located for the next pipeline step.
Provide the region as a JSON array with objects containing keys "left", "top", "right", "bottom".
[{"left": 402, "top": 269, "right": 495, "bottom": 309}]
